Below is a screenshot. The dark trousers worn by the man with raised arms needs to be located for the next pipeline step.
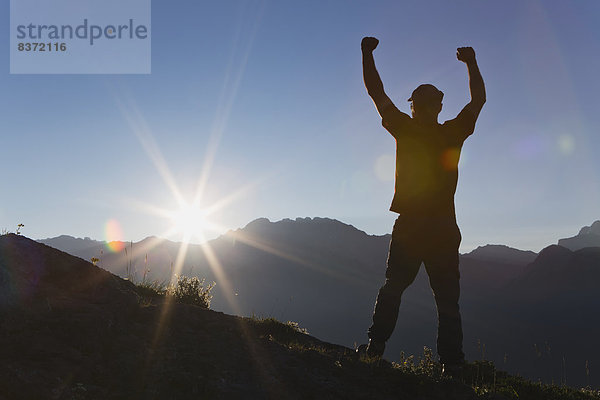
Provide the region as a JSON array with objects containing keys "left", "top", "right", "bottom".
[{"left": 369, "top": 215, "right": 464, "bottom": 364}]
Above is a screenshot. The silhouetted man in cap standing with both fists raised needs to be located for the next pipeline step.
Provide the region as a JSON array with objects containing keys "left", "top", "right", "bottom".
[{"left": 361, "top": 37, "right": 485, "bottom": 375}]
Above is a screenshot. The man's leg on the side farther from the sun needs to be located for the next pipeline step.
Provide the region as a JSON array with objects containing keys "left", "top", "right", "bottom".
[{"left": 425, "top": 223, "right": 465, "bottom": 365}]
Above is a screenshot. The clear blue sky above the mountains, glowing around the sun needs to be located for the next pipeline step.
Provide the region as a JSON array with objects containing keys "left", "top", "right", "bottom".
[{"left": 0, "top": 0, "right": 600, "bottom": 251}]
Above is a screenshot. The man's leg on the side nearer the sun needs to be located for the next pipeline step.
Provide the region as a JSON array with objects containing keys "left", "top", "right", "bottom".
[{"left": 369, "top": 217, "right": 421, "bottom": 352}]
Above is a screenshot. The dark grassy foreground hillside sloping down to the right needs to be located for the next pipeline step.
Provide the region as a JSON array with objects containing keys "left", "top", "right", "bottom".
[{"left": 0, "top": 234, "right": 600, "bottom": 400}]
